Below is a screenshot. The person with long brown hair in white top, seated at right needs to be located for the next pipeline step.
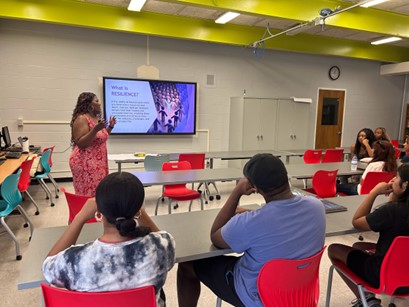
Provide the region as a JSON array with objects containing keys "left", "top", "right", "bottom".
[{"left": 337, "top": 141, "right": 397, "bottom": 195}]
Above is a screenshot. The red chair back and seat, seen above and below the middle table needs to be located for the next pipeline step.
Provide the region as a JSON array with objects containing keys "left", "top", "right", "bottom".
[{"left": 162, "top": 161, "right": 200, "bottom": 200}]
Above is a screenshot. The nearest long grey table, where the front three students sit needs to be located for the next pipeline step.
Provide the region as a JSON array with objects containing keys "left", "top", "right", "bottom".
[{"left": 17, "top": 195, "right": 386, "bottom": 290}]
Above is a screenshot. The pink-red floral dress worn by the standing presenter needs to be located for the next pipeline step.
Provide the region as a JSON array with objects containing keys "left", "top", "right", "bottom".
[{"left": 70, "top": 115, "right": 108, "bottom": 196}]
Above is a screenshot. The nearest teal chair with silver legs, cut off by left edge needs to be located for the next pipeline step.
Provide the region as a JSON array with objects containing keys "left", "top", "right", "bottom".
[{"left": 0, "top": 170, "right": 33, "bottom": 260}]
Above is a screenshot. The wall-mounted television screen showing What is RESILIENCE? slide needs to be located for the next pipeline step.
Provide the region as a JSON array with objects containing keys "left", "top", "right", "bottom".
[{"left": 103, "top": 77, "right": 197, "bottom": 135}]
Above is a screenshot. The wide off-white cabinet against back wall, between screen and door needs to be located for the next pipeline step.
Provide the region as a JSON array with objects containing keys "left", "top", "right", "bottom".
[{"left": 229, "top": 97, "right": 311, "bottom": 155}]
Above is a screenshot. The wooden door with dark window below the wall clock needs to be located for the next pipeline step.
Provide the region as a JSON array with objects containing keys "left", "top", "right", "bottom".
[{"left": 315, "top": 90, "right": 345, "bottom": 149}]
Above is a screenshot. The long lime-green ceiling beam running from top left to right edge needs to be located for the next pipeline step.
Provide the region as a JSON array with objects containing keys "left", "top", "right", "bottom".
[{"left": 0, "top": 0, "right": 409, "bottom": 62}]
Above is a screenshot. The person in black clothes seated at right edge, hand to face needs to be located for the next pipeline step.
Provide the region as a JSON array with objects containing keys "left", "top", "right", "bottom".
[{"left": 328, "top": 163, "right": 409, "bottom": 306}]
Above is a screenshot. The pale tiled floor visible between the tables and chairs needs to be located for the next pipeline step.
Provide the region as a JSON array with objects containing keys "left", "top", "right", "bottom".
[{"left": 0, "top": 177, "right": 409, "bottom": 307}]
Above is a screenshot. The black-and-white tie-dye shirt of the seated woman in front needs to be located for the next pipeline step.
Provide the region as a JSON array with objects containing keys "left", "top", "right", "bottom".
[{"left": 43, "top": 231, "right": 175, "bottom": 306}]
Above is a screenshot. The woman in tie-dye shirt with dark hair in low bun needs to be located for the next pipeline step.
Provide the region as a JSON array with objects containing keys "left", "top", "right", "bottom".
[{"left": 43, "top": 172, "right": 175, "bottom": 306}]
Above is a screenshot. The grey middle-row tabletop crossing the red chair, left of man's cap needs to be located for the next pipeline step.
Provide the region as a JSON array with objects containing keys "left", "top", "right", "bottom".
[{"left": 132, "top": 168, "right": 243, "bottom": 186}]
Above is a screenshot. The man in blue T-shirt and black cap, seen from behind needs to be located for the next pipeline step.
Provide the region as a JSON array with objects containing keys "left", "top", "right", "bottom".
[{"left": 177, "top": 154, "right": 325, "bottom": 307}]
